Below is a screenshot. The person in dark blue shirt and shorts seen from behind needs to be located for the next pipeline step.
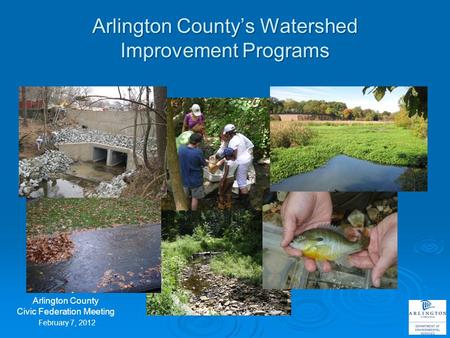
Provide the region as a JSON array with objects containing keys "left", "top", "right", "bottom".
[{"left": 178, "top": 133, "right": 206, "bottom": 210}]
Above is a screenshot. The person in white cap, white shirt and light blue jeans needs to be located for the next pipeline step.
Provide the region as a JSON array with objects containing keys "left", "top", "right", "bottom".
[{"left": 217, "top": 124, "right": 254, "bottom": 207}]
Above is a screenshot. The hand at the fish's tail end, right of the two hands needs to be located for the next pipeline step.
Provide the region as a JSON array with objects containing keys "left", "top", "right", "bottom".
[{"left": 350, "top": 213, "right": 397, "bottom": 287}]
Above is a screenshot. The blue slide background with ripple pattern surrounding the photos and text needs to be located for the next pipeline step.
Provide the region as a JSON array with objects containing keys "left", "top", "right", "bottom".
[{"left": 0, "top": 0, "right": 449, "bottom": 338}]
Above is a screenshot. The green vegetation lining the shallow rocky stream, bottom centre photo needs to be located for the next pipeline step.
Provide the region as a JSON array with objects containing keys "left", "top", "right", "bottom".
[{"left": 147, "top": 228, "right": 262, "bottom": 315}]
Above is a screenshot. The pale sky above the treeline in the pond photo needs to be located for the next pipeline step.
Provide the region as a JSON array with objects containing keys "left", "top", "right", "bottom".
[{"left": 270, "top": 87, "right": 408, "bottom": 113}]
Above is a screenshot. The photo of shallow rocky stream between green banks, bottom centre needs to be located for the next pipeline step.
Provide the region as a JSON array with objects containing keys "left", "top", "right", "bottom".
[{"left": 147, "top": 210, "right": 291, "bottom": 316}]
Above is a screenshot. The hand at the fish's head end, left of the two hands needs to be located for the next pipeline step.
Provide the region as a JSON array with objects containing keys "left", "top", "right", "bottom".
[{"left": 281, "top": 192, "right": 333, "bottom": 272}]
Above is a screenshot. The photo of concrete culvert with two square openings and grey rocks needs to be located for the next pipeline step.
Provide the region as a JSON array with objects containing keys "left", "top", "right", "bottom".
[{"left": 18, "top": 87, "right": 166, "bottom": 199}]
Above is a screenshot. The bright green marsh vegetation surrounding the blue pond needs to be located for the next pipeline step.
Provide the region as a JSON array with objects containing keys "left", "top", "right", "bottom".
[{"left": 270, "top": 121, "right": 427, "bottom": 183}]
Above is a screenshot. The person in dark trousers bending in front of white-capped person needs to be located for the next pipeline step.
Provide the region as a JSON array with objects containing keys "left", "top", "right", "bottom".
[{"left": 216, "top": 148, "right": 238, "bottom": 210}]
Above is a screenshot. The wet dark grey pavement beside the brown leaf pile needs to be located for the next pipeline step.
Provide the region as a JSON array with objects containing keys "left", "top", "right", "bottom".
[{"left": 27, "top": 224, "right": 161, "bottom": 292}]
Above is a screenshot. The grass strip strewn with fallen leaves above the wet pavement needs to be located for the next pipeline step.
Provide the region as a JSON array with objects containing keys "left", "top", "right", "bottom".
[{"left": 27, "top": 198, "right": 160, "bottom": 235}]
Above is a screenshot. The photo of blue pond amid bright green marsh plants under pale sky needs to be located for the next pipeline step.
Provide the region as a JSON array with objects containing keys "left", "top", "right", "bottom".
[{"left": 270, "top": 87, "right": 428, "bottom": 191}]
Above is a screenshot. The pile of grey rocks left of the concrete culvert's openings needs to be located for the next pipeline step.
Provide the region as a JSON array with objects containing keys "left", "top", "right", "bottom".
[{"left": 19, "top": 150, "right": 73, "bottom": 196}]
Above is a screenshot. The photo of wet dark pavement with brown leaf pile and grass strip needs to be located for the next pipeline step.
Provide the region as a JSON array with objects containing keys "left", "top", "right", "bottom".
[{"left": 26, "top": 198, "right": 161, "bottom": 293}]
